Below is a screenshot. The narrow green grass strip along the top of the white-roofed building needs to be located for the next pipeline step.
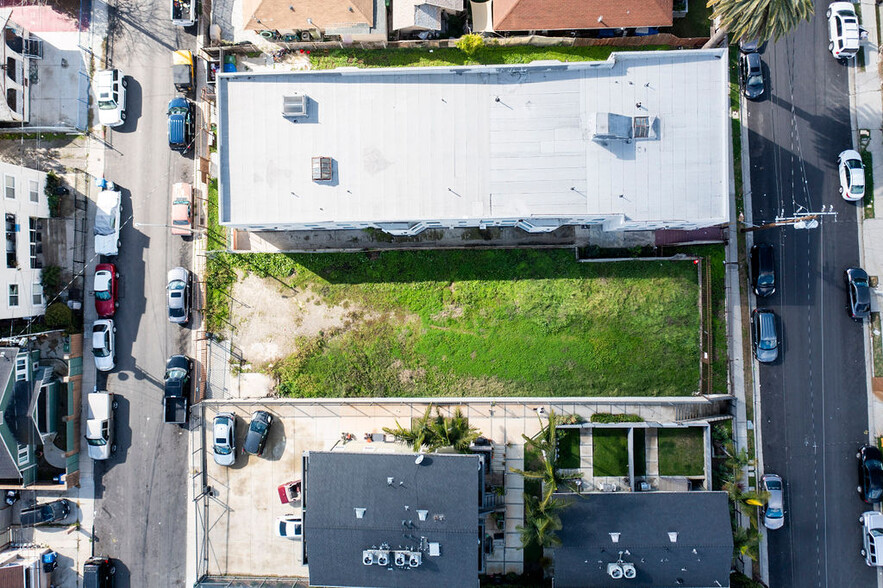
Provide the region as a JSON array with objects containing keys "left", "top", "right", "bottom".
[{"left": 310, "top": 45, "right": 671, "bottom": 69}]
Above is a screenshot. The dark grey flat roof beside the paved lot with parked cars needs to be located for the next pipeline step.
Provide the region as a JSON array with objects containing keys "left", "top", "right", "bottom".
[{"left": 303, "top": 452, "right": 484, "bottom": 588}]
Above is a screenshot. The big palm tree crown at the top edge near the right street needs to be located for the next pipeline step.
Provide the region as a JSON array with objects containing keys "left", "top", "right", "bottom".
[{"left": 705, "top": 0, "right": 814, "bottom": 47}]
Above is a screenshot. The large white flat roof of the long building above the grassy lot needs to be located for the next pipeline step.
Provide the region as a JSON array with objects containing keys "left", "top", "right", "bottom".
[{"left": 218, "top": 49, "right": 730, "bottom": 226}]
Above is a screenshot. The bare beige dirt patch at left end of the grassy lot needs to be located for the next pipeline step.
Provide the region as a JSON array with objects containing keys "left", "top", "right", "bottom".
[{"left": 228, "top": 274, "right": 365, "bottom": 367}]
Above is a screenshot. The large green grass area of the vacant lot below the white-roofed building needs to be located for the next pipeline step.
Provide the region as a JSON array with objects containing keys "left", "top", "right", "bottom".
[{"left": 223, "top": 248, "right": 704, "bottom": 397}]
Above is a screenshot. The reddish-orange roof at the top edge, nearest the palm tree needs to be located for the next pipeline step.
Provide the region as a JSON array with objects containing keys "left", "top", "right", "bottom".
[{"left": 492, "top": 0, "right": 672, "bottom": 31}]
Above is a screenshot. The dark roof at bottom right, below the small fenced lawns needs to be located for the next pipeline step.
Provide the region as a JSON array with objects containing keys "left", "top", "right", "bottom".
[{"left": 553, "top": 492, "right": 733, "bottom": 588}]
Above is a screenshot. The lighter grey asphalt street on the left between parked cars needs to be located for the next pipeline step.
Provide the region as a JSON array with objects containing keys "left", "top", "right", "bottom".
[{"left": 88, "top": 2, "right": 196, "bottom": 587}]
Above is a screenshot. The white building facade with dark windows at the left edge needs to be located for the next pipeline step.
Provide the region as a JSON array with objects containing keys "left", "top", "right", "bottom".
[{"left": 0, "top": 162, "right": 49, "bottom": 319}]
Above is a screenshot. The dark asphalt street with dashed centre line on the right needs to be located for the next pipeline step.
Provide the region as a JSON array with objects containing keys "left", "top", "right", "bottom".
[{"left": 748, "top": 2, "right": 877, "bottom": 588}]
